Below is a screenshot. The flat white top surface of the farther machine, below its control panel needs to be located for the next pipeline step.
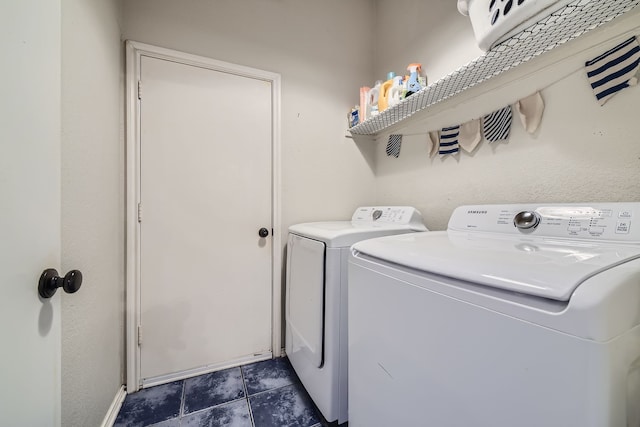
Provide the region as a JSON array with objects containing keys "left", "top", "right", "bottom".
[{"left": 289, "top": 221, "right": 414, "bottom": 248}]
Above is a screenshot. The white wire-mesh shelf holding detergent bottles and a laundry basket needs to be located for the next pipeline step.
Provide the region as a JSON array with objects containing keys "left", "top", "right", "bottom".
[{"left": 349, "top": 0, "right": 640, "bottom": 135}]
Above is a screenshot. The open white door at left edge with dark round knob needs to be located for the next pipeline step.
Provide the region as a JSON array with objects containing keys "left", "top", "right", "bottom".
[{"left": 0, "top": 0, "right": 62, "bottom": 427}]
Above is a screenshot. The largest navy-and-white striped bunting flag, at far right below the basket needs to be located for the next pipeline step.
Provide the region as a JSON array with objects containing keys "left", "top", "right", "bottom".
[{"left": 585, "top": 36, "right": 640, "bottom": 105}]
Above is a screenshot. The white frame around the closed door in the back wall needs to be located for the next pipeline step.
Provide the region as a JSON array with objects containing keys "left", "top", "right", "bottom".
[{"left": 125, "top": 40, "right": 282, "bottom": 393}]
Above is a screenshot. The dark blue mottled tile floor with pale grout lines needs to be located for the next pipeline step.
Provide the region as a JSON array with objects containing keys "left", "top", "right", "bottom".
[{"left": 114, "top": 357, "right": 322, "bottom": 427}]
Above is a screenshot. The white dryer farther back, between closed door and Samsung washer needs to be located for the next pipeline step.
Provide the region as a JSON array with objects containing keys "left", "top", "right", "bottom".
[{"left": 285, "top": 206, "right": 426, "bottom": 423}]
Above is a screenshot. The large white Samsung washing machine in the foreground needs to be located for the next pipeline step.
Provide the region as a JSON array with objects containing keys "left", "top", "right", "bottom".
[{"left": 348, "top": 203, "right": 640, "bottom": 427}]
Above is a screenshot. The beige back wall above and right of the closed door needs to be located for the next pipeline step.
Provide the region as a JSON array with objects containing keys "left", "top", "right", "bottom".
[{"left": 124, "top": 0, "right": 375, "bottom": 234}]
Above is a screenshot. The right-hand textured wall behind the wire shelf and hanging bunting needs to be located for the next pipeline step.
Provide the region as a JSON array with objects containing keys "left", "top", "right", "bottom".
[{"left": 375, "top": 0, "right": 640, "bottom": 230}]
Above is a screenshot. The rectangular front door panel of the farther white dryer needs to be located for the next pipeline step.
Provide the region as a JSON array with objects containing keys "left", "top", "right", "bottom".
[{"left": 286, "top": 234, "right": 326, "bottom": 367}]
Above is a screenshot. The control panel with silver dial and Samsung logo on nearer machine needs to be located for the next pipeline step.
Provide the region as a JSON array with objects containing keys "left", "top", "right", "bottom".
[{"left": 448, "top": 203, "right": 640, "bottom": 243}]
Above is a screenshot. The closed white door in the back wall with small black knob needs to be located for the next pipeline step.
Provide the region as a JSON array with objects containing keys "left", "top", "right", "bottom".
[{"left": 139, "top": 51, "right": 273, "bottom": 385}]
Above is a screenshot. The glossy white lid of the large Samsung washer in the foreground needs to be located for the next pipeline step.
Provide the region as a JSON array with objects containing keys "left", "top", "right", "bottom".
[{"left": 353, "top": 231, "right": 640, "bottom": 301}]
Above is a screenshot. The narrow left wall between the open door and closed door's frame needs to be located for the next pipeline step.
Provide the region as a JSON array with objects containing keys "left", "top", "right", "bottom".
[{"left": 61, "top": 0, "right": 125, "bottom": 426}]
